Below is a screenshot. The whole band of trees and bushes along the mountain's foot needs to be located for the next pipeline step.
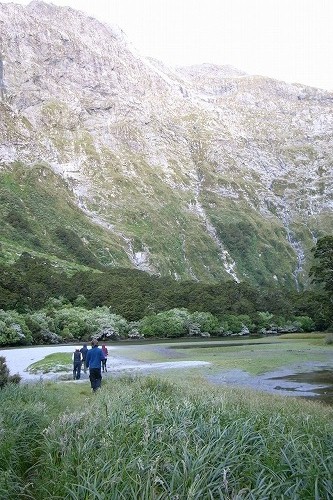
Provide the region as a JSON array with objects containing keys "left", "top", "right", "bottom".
[{"left": 0, "top": 236, "right": 333, "bottom": 345}]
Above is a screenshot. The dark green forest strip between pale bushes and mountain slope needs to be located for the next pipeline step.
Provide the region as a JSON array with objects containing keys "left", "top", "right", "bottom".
[{"left": 0, "top": 252, "right": 333, "bottom": 330}]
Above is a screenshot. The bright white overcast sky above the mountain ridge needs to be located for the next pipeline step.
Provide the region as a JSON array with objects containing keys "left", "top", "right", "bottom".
[{"left": 0, "top": 0, "right": 333, "bottom": 90}]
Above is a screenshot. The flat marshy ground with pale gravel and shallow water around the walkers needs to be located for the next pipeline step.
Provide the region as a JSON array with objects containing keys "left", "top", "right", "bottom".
[{"left": 0, "top": 335, "right": 333, "bottom": 405}]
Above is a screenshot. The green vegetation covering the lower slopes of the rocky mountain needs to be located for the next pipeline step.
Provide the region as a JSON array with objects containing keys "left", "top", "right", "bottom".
[{"left": 0, "top": 156, "right": 329, "bottom": 288}]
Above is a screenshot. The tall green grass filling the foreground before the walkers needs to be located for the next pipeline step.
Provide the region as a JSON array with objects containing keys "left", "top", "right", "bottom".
[{"left": 0, "top": 377, "right": 333, "bottom": 500}]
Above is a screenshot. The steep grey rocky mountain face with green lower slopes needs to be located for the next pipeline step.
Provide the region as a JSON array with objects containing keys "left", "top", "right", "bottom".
[{"left": 0, "top": 1, "right": 333, "bottom": 288}]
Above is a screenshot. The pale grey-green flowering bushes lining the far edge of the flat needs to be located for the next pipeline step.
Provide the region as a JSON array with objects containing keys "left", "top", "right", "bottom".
[{"left": 0, "top": 297, "right": 322, "bottom": 345}]
